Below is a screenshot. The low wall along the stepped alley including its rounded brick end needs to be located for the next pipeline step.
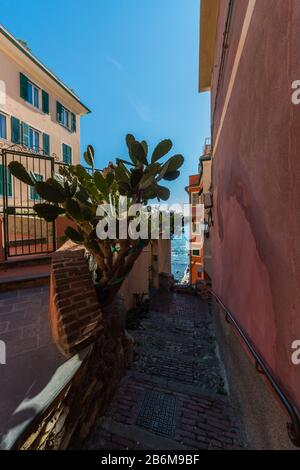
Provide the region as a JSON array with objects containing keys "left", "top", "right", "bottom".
[{"left": 16, "top": 242, "right": 133, "bottom": 450}]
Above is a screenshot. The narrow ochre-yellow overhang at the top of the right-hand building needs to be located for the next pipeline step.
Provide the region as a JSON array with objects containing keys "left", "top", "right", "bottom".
[{"left": 199, "top": 0, "right": 220, "bottom": 93}]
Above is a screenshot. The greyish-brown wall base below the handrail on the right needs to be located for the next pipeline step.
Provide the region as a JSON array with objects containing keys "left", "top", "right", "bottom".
[{"left": 212, "top": 301, "right": 297, "bottom": 450}]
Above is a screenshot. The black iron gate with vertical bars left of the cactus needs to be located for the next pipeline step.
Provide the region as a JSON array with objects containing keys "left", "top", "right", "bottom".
[{"left": 0, "top": 147, "right": 55, "bottom": 259}]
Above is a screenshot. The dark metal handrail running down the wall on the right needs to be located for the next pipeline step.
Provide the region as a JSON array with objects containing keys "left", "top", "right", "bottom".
[{"left": 206, "top": 286, "right": 300, "bottom": 447}]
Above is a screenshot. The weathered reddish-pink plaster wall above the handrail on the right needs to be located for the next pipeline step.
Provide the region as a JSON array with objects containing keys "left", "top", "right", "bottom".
[{"left": 212, "top": 0, "right": 300, "bottom": 407}]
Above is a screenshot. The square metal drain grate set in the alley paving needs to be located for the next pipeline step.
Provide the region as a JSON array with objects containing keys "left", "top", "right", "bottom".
[{"left": 136, "top": 390, "right": 176, "bottom": 437}]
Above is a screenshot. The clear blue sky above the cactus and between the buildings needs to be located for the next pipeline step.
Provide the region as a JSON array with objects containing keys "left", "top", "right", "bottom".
[{"left": 0, "top": 0, "right": 210, "bottom": 202}]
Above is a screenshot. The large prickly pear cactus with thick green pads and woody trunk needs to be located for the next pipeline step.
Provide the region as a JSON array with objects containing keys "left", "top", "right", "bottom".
[{"left": 9, "top": 134, "right": 184, "bottom": 304}]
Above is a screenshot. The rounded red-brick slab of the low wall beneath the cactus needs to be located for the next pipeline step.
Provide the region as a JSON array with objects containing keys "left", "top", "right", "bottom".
[{"left": 49, "top": 242, "right": 103, "bottom": 356}]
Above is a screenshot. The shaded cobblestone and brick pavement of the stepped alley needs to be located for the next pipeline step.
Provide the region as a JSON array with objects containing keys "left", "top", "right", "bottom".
[{"left": 85, "top": 292, "right": 244, "bottom": 450}]
